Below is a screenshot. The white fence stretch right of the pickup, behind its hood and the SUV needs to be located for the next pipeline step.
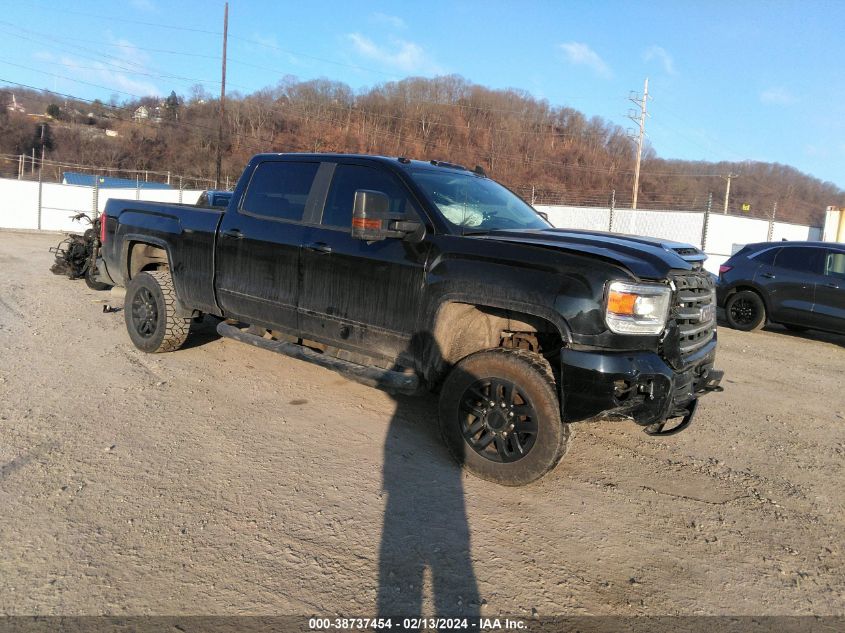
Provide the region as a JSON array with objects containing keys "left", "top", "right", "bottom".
[{"left": 537, "top": 206, "right": 822, "bottom": 273}]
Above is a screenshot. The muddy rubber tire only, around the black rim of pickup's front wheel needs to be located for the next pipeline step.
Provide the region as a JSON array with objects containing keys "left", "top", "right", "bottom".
[{"left": 439, "top": 349, "right": 570, "bottom": 486}]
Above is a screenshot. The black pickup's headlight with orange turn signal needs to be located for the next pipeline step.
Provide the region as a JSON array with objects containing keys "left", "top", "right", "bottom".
[{"left": 604, "top": 281, "right": 672, "bottom": 334}]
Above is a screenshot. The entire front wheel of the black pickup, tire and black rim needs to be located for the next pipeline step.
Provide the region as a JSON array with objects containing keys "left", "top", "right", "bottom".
[{"left": 440, "top": 349, "right": 569, "bottom": 486}]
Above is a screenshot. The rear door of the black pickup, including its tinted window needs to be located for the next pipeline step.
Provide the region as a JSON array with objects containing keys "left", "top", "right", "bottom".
[{"left": 216, "top": 160, "right": 320, "bottom": 331}]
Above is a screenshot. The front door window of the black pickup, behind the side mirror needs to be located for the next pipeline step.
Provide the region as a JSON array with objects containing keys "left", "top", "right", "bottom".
[{"left": 322, "top": 165, "right": 417, "bottom": 229}]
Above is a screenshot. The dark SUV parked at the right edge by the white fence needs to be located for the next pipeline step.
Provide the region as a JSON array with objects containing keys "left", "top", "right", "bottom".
[{"left": 717, "top": 242, "right": 845, "bottom": 334}]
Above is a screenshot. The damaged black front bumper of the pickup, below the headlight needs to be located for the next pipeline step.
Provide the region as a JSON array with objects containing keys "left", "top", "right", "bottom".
[{"left": 561, "top": 337, "right": 722, "bottom": 430}]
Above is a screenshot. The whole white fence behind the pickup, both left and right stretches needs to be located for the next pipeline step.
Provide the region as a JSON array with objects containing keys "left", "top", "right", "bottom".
[{"left": 0, "top": 179, "right": 822, "bottom": 272}]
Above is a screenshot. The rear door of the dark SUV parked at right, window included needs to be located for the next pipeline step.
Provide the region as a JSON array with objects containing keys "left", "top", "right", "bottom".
[{"left": 755, "top": 246, "right": 823, "bottom": 327}]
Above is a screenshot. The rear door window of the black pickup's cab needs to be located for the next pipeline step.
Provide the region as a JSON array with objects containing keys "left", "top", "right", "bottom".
[{"left": 241, "top": 161, "right": 320, "bottom": 222}]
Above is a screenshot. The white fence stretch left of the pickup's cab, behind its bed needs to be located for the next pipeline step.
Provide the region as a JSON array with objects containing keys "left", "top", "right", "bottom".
[{"left": 0, "top": 178, "right": 202, "bottom": 231}]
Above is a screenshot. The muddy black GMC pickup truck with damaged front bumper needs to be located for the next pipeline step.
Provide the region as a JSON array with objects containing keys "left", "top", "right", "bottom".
[{"left": 97, "top": 154, "right": 722, "bottom": 485}]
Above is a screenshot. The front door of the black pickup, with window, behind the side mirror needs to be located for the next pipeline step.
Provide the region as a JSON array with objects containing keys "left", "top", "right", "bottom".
[{"left": 299, "top": 162, "right": 428, "bottom": 359}]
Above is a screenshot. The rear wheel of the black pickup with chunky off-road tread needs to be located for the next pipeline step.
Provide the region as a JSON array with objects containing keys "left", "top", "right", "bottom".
[{"left": 123, "top": 270, "right": 191, "bottom": 353}]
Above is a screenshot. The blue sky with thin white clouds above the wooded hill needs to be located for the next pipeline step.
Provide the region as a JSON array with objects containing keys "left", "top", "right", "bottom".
[{"left": 0, "top": 0, "right": 845, "bottom": 188}]
